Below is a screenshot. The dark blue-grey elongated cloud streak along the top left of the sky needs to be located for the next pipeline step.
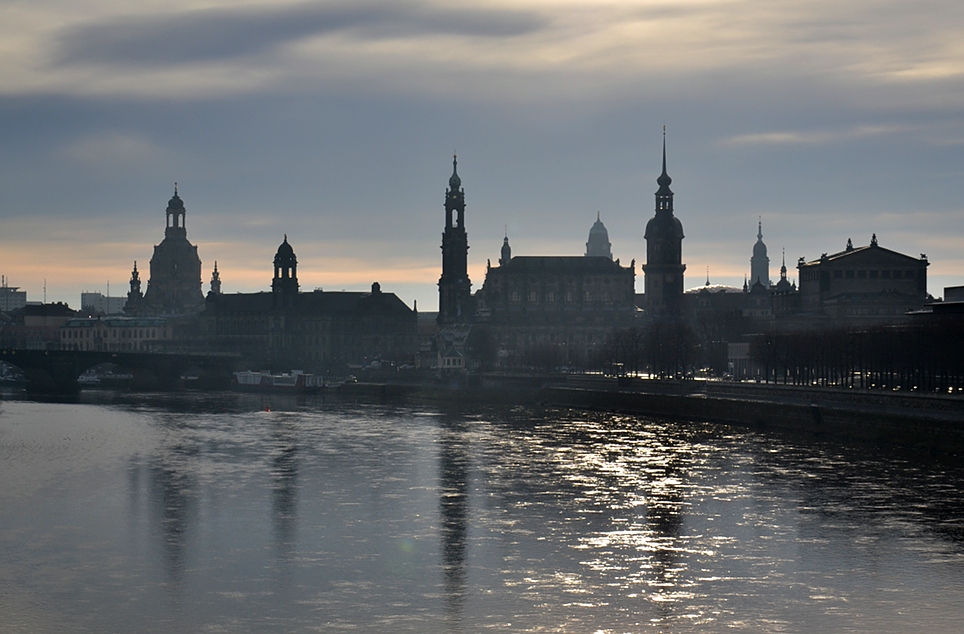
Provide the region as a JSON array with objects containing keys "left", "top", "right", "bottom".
[{"left": 56, "top": 0, "right": 546, "bottom": 67}]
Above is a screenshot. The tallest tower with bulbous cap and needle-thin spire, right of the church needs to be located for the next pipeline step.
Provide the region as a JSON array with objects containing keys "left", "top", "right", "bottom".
[{"left": 643, "top": 126, "right": 686, "bottom": 318}]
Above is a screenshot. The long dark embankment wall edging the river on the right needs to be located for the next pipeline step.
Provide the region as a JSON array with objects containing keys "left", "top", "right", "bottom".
[{"left": 343, "top": 375, "right": 964, "bottom": 454}]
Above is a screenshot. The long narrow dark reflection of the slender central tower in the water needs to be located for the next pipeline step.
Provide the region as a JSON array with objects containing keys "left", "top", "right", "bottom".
[{"left": 439, "top": 419, "right": 469, "bottom": 622}]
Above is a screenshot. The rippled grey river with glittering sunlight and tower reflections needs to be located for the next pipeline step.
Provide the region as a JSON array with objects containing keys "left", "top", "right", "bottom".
[{"left": 0, "top": 393, "right": 964, "bottom": 633}]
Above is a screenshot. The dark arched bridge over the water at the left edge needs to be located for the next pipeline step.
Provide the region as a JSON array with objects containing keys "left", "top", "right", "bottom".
[{"left": 0, "top": 349, "right": 241, "bottom": 393}]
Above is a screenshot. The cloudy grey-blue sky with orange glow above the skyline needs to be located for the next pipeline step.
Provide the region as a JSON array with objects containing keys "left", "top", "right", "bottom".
[{"left": 0, "top": 0, "right": 964, "bottom": 311}]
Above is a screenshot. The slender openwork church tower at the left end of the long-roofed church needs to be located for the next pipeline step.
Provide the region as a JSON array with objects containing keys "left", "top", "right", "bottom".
[{"left": 438, "top": 156, "right": 473, "bottom": 325}]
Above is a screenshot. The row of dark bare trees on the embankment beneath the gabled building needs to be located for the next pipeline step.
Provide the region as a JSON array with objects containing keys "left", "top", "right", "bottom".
[{"left": 750, "top": 315, "right": 964, "bottom": 392}]
